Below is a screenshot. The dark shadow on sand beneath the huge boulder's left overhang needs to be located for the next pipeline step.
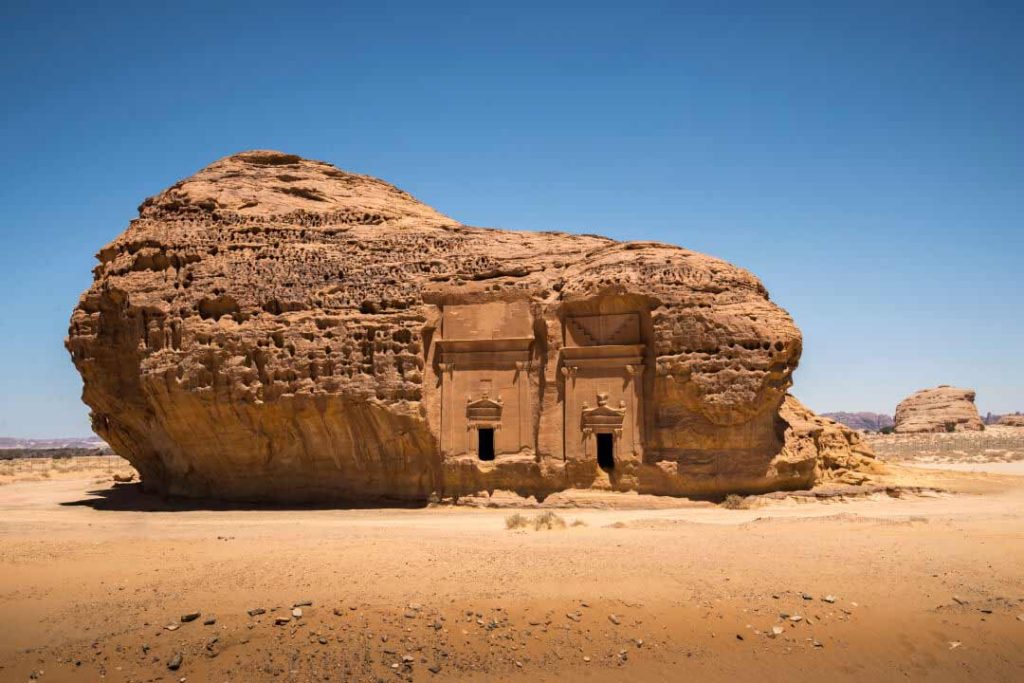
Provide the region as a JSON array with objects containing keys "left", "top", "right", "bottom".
[{"left": 60, "top": 483, "right": 428, "bottom": 512}]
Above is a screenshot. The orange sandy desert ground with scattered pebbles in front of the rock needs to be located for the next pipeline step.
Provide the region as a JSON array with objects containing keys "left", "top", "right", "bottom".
[{"left": 0, "top": 456, "right": 1024, "bottom": 681}]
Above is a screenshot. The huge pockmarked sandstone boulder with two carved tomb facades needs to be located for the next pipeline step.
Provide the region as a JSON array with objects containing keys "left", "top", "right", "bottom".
[{"left": 67, "top": 151, "right": 871, "bottom": 502}]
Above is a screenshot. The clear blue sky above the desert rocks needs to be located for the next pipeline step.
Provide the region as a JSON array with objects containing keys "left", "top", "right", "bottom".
[{"left": 0, "top": 0, "right": 1024, "bottom": 436}]
